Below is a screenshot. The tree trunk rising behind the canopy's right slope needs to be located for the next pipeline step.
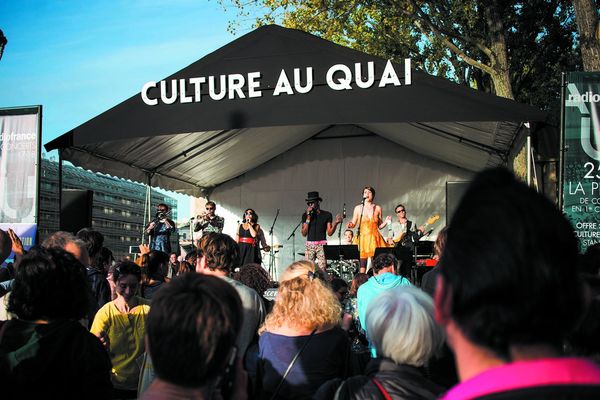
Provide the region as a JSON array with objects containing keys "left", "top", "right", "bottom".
[{"left": 484, "top": 1, "right": 515, "bottom": 99}]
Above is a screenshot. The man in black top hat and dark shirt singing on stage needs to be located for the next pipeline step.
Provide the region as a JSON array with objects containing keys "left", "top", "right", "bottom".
[{"left": 302, "top": 192, "right": 342, "bottom": 271}]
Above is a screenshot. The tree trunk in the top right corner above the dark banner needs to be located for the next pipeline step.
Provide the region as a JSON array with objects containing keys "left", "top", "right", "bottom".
[{"left": 573, "top": 0, "right": 600, "bottom": 71}]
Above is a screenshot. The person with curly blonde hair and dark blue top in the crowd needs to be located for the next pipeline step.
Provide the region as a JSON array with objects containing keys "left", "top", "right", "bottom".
[{"left": 258, "top": 260, "right": 350, "bottom": 399}]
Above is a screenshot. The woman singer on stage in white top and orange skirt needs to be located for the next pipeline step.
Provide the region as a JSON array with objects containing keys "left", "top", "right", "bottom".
[{"left": 348, "top": 186, "right": 391, "bottom": 273}]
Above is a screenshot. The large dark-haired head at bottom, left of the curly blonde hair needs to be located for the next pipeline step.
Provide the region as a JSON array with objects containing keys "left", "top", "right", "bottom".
[{"left": 146, "top": 274, "right": 243, "bottom": 388}]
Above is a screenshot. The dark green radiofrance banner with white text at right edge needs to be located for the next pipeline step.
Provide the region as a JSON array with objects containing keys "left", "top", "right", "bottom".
[{"left": 562, "top": 72, "right": 600, "bottom": 252}]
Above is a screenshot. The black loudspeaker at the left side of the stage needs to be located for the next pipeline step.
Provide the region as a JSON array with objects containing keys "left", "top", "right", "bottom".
[{"left": 60, "top": 189, "right": 94, "bottom": 234}]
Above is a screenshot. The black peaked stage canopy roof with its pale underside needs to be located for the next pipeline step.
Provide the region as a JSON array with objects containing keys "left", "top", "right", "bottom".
[{"left": 45, "top": 25, "right": 545, "bottom": 195}]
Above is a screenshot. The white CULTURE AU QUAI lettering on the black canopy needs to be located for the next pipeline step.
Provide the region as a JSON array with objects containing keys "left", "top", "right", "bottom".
[{"left": 140, "top": 58, "right": 412, "bottom": 106}]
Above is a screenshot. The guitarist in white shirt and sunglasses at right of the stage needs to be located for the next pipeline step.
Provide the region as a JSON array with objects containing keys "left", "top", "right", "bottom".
[{"left": 387, "top": 204, "right": 425, "bottom": 278}]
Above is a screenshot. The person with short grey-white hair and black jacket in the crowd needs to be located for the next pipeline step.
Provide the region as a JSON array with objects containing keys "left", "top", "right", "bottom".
[{"left": 315, "top": 286, "right": 445, "bottom": 400}]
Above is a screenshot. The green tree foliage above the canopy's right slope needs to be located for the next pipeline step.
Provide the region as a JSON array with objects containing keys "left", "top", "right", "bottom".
[{"left": 219, "top": 0, "right": 581, "bottom": 109}]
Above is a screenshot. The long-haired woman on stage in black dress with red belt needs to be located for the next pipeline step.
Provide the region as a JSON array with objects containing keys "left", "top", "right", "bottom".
[{"left": 236, "top": 208, "right": 271, "bottom": 265}]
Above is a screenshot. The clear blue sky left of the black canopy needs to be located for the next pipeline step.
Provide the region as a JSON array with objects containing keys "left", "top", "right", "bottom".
[{"left": 0, "top": 0, "right": 258, "bottom": 219}]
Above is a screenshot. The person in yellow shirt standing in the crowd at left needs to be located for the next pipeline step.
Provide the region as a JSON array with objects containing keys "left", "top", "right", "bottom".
[{"left": 90, "top": 261, "right": 150, "bottom": 399}]
